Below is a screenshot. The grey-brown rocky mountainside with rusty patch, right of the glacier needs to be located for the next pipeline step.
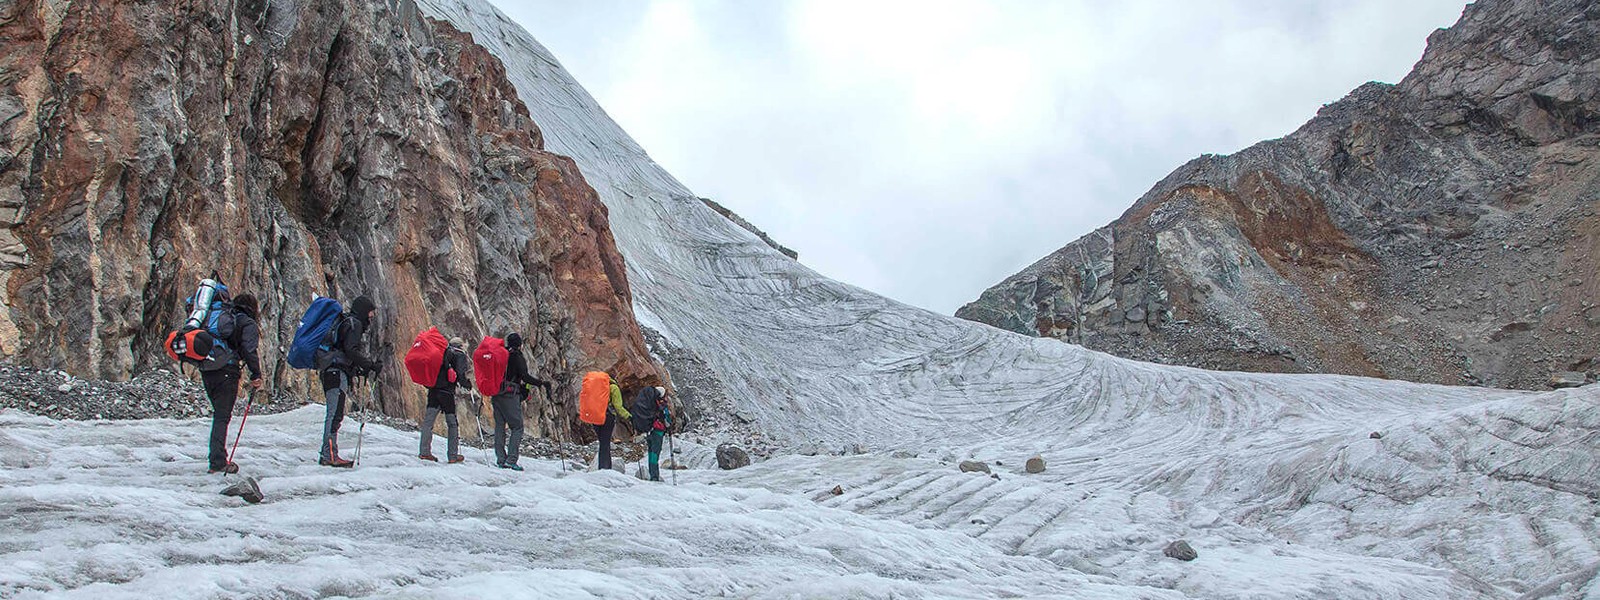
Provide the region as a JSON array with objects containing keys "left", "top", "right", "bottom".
[{"left": 957, "top": 0, "right": 1600, "bottom": 387}]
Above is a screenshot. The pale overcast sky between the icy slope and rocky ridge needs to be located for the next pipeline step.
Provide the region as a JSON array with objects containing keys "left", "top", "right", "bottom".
[{"left": 496, "top": 0, "right": 1466, "bottom": 314}]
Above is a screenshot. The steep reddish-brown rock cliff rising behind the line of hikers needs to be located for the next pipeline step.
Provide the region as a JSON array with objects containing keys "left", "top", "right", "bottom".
[{"left": 0, "top": 0, "right": 661, "bottom": 438}]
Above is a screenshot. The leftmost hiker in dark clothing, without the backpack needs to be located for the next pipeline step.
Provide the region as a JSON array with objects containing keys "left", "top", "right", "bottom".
[{"left": 200, "top": 294, "right": 261, "bottom": 474}]
